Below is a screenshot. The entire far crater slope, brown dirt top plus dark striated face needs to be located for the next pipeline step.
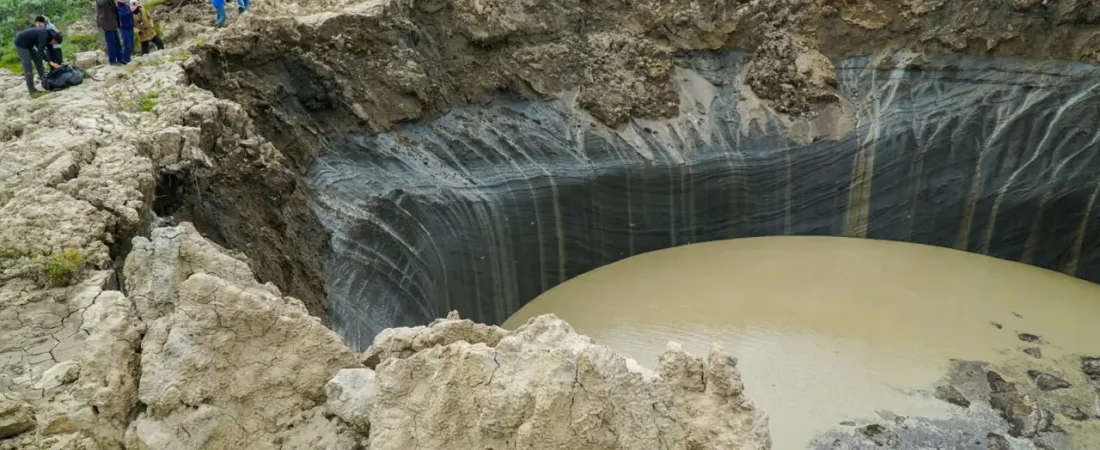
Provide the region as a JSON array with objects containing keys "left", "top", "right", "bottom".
[{"left": 189, "top": 1, "right": 1100, "bottom": 347}]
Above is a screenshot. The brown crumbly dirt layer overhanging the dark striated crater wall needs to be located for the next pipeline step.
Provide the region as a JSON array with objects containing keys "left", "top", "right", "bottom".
[{"left": 188, "top": 0, "right": 1100, "bottom": 140}]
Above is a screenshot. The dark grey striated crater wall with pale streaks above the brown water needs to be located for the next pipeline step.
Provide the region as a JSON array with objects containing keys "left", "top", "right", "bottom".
[{"left": 309, "top": 53, "right": 1100, "bottom": 348}]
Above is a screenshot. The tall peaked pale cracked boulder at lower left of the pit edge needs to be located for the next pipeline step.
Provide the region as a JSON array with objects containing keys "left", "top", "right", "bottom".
[{"left": 127, "top": 223, "right": 359, "bottom": 449}]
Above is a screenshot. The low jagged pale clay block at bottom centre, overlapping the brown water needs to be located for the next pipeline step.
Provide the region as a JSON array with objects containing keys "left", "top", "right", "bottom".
[{"left": 360, "top": 315, "right": 770, "bottom": 450}]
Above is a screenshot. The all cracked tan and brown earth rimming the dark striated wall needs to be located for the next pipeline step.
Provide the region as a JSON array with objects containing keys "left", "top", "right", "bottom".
[{"left": 8, "top": 0, "right": 1100, "bottom": 450}]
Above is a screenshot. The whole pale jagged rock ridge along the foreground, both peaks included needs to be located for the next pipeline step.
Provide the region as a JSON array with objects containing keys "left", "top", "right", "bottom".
[{"left": 0, "top": 223, "right": 770, "bottom": 450}]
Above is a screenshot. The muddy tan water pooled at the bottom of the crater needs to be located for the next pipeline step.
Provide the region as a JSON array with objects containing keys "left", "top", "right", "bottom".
[{"left": 504, "top": 237, "right": 1100, "bottom": 449}]
